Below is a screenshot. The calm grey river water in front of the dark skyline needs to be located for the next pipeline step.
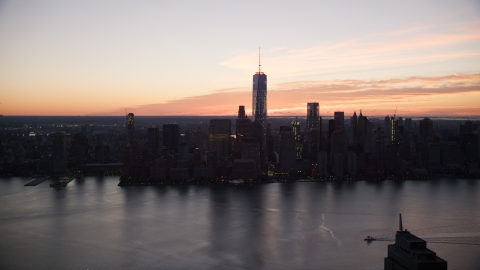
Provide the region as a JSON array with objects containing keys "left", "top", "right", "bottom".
[{"left": 0, "top": 177, "right": 480, "bottom": 269}]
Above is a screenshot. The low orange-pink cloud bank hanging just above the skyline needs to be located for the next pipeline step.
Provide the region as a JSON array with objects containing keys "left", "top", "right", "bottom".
[{"left": 96, "top": 73, "right": 480, "bottom": 116}]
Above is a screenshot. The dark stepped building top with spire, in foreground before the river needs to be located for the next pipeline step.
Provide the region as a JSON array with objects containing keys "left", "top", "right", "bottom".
[{"left": 384, "top": 214, "right": 447, "bottom": 270}]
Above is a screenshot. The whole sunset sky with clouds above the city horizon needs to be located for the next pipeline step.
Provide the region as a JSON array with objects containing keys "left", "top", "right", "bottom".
[{"left": 0, "top": 0, "right": 480, "bottom": 116}]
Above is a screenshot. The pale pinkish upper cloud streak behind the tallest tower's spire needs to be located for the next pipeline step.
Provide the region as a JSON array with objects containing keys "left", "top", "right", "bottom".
[{"left": 220, "top": 22, "right": 480, "bottom": 81}]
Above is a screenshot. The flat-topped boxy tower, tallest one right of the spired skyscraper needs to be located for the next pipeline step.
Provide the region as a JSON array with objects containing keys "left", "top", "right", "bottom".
[{"left": 306, "top": 102, "right": 321, "bottom": 161}]
